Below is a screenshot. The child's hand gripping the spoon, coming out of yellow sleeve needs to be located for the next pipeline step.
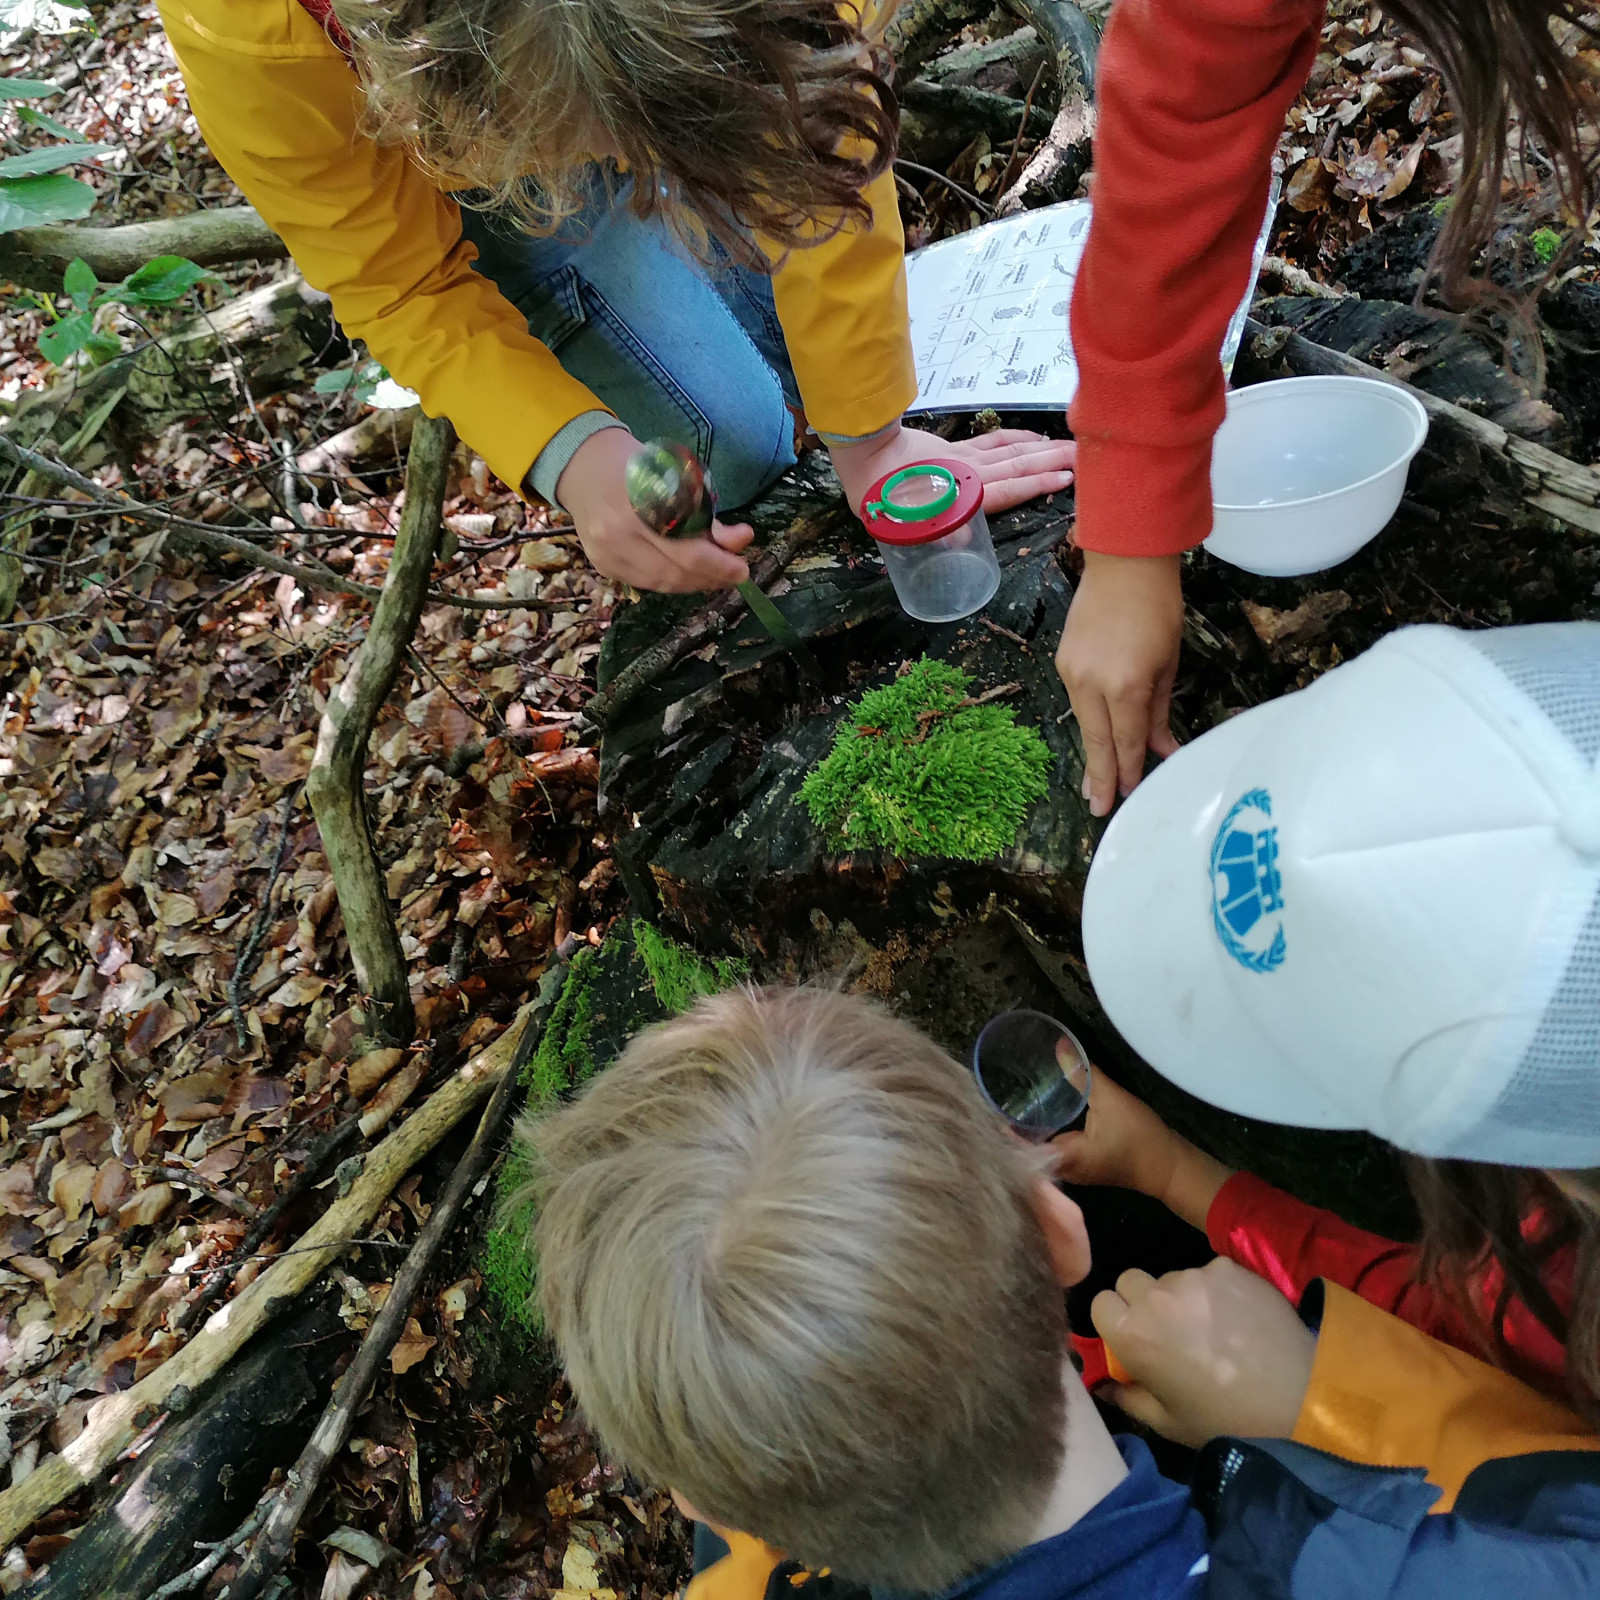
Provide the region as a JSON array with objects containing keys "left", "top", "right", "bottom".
[{"left": 555, "top": 427, "right": 755, "bottom": 594}]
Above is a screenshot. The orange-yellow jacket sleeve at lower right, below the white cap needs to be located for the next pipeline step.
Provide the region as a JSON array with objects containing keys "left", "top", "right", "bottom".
[{"left": 1291, "top": 1280, "right": 1600, "bottom": 1512}]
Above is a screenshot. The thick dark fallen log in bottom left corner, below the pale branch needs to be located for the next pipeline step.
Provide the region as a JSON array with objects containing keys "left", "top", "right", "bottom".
[{"left": 30, "top": 1298, "right": 350, "bottom": 1600}]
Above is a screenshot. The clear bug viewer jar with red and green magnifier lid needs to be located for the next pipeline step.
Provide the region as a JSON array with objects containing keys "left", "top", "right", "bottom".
[{"left": 861, "top": 461, "right": 1000, "bottom": 622}]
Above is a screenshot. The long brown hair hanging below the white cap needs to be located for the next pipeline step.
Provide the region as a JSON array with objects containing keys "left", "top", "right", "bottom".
[{"left": 1406, "top": 1155, "right": 1600, "bottom": 1426}]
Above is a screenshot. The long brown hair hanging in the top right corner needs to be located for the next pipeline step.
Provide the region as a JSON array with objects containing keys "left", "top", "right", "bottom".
[{"left": 1384, "top": 0, "right": 1600, "bottom": 301}]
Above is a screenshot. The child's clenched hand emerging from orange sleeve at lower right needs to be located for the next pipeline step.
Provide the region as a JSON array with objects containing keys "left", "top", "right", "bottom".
[{"left": 1090, "top": 1256, "right": 1317, "bottom": 1448}]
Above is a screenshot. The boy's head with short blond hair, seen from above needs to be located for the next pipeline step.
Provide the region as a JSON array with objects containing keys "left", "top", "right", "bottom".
[{"left": 520, "top": 989, "right": 1066, "bottom": 1592}]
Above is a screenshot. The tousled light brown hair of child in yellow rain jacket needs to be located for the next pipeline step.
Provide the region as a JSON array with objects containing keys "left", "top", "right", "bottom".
[{"left": 324, "top": 0, "right": 899, "bottom": 266}]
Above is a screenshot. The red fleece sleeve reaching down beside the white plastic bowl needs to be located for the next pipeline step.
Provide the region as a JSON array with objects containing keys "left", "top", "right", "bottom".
[{"left": 1072, "top": 0, "right": 1322, "bottom": 555}]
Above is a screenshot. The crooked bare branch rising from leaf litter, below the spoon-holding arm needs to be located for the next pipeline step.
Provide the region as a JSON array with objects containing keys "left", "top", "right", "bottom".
[{"left": 306, "top": 406, "right": 456, "bottom": 1045}]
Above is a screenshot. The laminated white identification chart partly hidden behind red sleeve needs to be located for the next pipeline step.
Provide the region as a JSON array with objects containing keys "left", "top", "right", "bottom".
[{"left": 906, "top": 181, "right": 1278, "bottom": 411}]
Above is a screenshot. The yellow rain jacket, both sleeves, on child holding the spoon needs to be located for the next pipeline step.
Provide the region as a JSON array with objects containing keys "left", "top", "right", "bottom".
[{"left": 158, "top": 0, "right": 917, "bottom": 486}]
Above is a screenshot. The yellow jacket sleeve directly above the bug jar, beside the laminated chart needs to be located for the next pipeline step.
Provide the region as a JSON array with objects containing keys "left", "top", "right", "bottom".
[{"left": 758, "top": 171, "right": 917, "bottom": 440}]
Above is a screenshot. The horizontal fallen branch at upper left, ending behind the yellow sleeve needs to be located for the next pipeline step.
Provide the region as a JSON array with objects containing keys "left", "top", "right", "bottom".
[{"left": 0, "top": 205, "right": 290, "bottom": 294}]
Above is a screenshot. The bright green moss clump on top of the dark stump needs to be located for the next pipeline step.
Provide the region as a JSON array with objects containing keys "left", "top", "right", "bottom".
[{"left": 798, "top": 659, "right": 1054, "bottom": 861}]
